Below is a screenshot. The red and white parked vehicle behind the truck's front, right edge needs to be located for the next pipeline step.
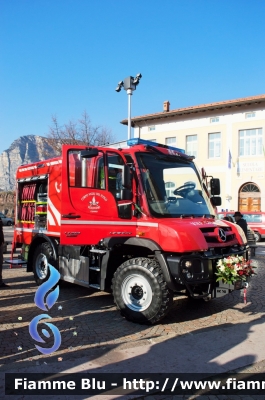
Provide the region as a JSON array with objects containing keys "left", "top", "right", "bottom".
[{"left": 216, "top": 211, "right": 265, "bottom": 242}]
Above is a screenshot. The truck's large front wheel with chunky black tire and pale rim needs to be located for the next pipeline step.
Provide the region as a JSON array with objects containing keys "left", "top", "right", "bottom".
[{"left": 112, "top": 258, "right": 173, "bottom": 324}]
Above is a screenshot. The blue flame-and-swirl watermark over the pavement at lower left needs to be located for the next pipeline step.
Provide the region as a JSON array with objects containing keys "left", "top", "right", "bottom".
[{"left": 29, "top": 264, "right": 61, "bottom": 354}]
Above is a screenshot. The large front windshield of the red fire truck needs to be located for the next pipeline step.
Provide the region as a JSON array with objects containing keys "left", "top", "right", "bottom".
[{"left": 137, "top": 153, "right": 215, "bottom": 218}]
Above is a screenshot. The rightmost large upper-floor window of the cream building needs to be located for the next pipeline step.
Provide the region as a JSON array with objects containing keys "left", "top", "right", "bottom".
[{"left": 239, "top": 128, "right": 262, "bottom": 156}]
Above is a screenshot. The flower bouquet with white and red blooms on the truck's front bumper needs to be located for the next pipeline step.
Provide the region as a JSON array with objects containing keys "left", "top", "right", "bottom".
[{"left": 215, "top": 255, "right": 255, "bottom": 285}]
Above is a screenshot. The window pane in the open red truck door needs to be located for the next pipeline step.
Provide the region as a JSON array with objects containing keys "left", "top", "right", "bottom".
[{"left": 68, "top": 150, "right": 106, "bottom": 189}]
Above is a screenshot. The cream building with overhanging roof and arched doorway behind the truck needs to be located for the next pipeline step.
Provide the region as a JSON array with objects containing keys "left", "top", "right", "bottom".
[{"left": 121, "top": 95, "right": 265, "bottom": 211}]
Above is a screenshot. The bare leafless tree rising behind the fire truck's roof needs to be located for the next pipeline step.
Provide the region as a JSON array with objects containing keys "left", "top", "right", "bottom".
[{"left": 47, "top": 111, "right": 115, "bottom": 155}]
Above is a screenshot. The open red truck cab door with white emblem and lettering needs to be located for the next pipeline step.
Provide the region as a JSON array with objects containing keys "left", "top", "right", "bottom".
[{"left": 61, "top": 146, "right": 132, "bottom": 244}]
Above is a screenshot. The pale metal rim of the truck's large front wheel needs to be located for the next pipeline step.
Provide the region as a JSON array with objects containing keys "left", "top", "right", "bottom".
[{"left": 121, "top": 274, "right": 153, "bottom": 312}]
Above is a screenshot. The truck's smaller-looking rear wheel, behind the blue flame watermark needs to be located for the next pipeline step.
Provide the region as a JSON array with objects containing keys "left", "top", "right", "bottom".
[{"left": 33, "top": 242, "right": 55, "bottom": 285}]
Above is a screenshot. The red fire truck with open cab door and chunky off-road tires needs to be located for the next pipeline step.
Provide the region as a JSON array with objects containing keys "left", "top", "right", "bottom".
[{"left": 12, "top": 139, "right": 248, "bottom": 323}]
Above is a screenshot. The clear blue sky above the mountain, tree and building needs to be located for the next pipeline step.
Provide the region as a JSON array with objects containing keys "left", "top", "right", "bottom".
[{"left": 0, "top": 0, "right": 265, "bottom": 153}]
